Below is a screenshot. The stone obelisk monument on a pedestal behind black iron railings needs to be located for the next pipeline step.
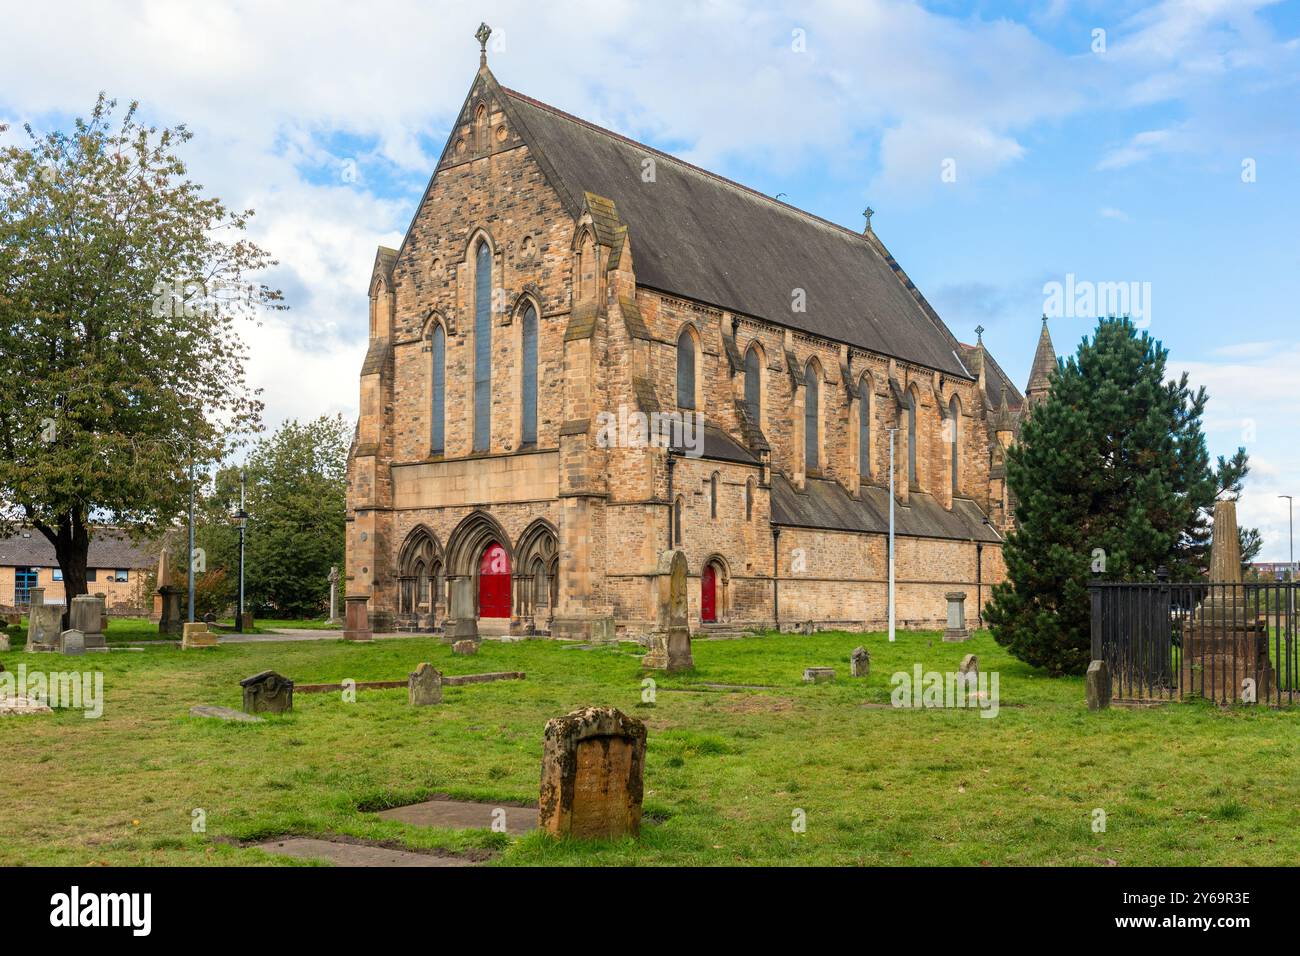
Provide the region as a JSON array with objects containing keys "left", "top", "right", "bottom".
[{"left": 1182, "top": 501, "right": 1274, "bottom": 704}]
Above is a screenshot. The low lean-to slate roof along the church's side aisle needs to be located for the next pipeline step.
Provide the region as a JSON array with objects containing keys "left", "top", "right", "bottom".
[{"left": 772, "top": 475, "right": 1002, "bottom": 544}]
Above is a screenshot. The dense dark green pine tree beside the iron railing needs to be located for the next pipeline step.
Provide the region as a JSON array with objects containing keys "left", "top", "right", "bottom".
[{"left": 987, "top": 319, "right": 1248, "bottom": 675}]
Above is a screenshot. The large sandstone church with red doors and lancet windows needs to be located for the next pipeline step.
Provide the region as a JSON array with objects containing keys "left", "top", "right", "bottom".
[{"left": 347, "top": 27, "right": 1056, "bottom": 640}]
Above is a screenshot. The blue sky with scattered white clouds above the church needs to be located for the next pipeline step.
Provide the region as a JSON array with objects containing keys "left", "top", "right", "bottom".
[{"left": 0, "top": 0, "right": 1300, "bottom": 559}]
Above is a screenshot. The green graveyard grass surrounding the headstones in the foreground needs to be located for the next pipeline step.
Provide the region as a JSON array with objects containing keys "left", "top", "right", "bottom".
[{"left": 0, "top": 633, "right": 1300, "bottom": 866}]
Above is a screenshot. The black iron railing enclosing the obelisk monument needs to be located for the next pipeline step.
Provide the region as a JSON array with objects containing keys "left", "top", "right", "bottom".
[{"left": 1091, "top": 581, "right": 1300, "bottom": 706}]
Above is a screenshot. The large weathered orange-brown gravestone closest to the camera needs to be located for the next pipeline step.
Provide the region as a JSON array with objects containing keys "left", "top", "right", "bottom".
[{"left": 537, "top": 708, "right": 646, "bottom": 839}]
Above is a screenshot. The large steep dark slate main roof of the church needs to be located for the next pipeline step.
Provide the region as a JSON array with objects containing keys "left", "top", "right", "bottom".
[{"left": 502, "top": 87, "right": 970, "bottom": 377}]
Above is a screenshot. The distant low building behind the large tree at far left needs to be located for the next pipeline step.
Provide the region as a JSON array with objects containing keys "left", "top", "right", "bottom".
[{"left": 0, "top": 528, "right": 157, "bottom": 609}]
